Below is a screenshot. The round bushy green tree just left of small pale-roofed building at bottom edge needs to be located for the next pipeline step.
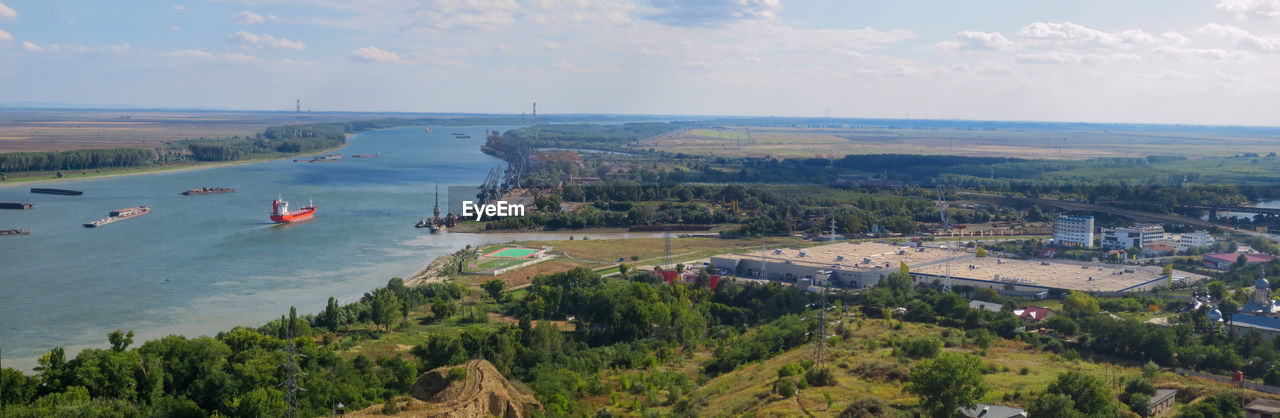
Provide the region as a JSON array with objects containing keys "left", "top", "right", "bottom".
[{"left": 905, "top": 353, "right": 988, "bottom": 417}]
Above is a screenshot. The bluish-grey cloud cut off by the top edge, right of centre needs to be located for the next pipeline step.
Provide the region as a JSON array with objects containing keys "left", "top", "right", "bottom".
[{"left": 649, "top": 0, "right": 782, "bottom": 26}]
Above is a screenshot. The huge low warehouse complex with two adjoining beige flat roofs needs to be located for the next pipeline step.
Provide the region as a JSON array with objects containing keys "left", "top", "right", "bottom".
[{"left": 710, "top": 243, "right": 1203, "bottom": 293}]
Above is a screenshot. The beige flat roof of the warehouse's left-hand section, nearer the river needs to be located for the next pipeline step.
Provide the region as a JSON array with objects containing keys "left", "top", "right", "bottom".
[{"left": 716, "top": 242, "right": 973, "bottom": 270}]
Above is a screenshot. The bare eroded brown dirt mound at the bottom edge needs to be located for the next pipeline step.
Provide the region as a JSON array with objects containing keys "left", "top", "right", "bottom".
[{"left": 353, "top": 360, "right": 543, "bottom": 418}]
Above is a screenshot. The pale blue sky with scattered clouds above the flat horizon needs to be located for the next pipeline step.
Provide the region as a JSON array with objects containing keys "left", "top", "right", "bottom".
[{"left": 0, "top": 0, "right": 1280, "bottom": 125}]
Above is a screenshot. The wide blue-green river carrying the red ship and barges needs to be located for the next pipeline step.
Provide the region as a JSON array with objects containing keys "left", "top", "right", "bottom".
[{"left": 0, "top": 127, "right": 547, "bottom": 369}]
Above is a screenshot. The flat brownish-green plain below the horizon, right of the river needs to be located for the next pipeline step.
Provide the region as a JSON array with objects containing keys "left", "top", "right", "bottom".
[{"left": 641, "top": 127, "right": 1280, "bottom": 160}]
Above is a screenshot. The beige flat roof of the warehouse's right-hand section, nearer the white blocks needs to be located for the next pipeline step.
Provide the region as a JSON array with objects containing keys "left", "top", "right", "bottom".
[{"left": 911, "top": 257, "right": 1203, "bottom": 291}]
